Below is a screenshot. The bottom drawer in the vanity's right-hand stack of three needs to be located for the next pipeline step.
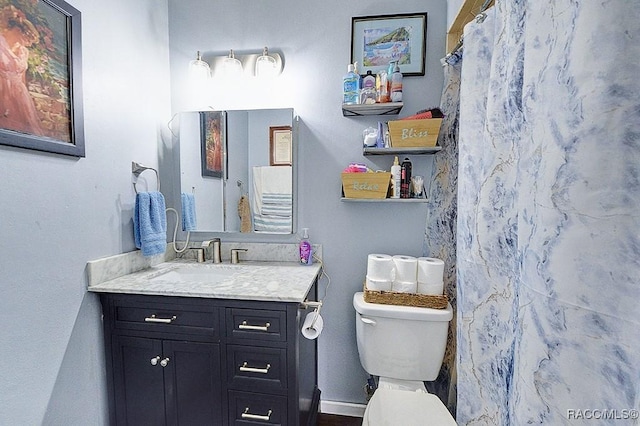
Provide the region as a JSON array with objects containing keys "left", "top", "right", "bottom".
[{"left": 229, "top": 391, "right": 287, "bottom": 426}]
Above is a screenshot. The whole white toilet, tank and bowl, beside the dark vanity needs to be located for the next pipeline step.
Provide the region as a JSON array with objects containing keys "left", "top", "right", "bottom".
[{"left": 353, "top": 292, "right": 456, "bottom": 426}]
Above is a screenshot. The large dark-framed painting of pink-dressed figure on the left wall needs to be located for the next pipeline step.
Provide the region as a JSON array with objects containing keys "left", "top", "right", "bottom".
[{"left": 0, "top": 0, "right": 85, "bottom": 157}]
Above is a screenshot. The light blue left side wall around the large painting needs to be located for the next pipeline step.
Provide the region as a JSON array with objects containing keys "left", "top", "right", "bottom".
[{"left": 0, "top": 0, "right": 170, "bottom": 426}]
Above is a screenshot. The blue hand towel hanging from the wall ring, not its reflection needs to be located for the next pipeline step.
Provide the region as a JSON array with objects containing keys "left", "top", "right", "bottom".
[{"left": 133, "top": 192, "right": 167, "bottom": 256}]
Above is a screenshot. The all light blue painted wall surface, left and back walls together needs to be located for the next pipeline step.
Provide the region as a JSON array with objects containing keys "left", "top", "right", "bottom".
[{"left": 0, "top": 0, "right": 446, "bottom": 425}]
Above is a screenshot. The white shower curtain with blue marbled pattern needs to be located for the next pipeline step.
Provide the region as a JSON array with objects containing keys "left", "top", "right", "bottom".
[{"left": 456, "top": 0, "right": 640, "bottom": 426}]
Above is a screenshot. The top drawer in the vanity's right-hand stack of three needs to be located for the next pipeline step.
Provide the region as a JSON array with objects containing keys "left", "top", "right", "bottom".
[{"left": 226, "top": 308, "right": 287, "bottom": 342}]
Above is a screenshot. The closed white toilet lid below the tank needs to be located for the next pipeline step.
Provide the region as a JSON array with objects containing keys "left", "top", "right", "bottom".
[{"left": 363, "top": 388, "right": 456, "bottom": 426}]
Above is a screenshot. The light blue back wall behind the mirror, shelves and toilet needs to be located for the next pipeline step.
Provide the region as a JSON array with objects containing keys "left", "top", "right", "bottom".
[{"left": 165, "top": 0, "right": 447, "bottom": 403}]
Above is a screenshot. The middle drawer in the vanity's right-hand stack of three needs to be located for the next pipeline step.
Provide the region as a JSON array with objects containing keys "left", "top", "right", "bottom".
[{"left": 227, "top": 345, "right": 287, "bottom": 391}]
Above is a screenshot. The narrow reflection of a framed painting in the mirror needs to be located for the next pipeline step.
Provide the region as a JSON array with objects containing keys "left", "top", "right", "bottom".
[{"left": 200, "top": 111, "right": 227, "bottom": 178}]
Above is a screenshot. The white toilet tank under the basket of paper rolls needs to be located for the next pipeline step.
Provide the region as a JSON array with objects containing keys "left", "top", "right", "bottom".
[{"left": 353, "top": 292, "right": 453, "bottom": 381}]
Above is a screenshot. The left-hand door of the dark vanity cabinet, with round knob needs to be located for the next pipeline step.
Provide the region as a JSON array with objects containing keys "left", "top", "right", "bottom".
[{"left": 113, "top": 335, "right": 165, "bottom": 426}]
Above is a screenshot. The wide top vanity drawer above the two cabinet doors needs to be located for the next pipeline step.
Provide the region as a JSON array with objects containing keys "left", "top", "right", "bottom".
[{"left": 114, "top": 301, "right": 219, "bottom": 337}]
